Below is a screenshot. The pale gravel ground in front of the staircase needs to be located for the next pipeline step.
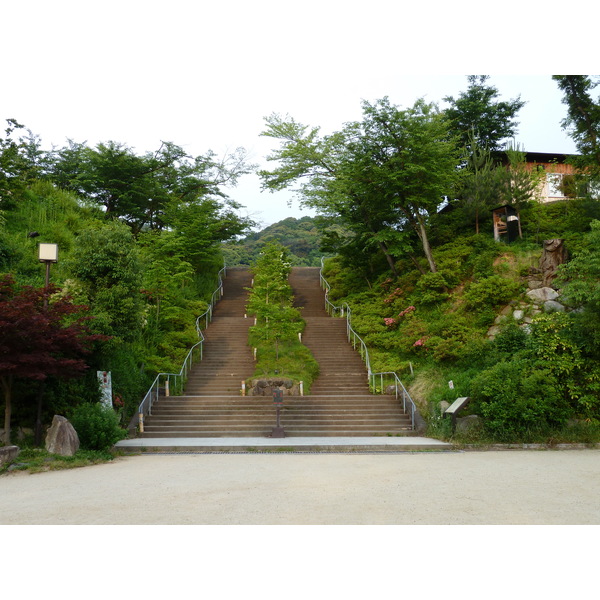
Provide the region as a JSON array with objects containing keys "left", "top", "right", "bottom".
[{"left": 0, "top": 450, "right": 600, "bottom": 525}]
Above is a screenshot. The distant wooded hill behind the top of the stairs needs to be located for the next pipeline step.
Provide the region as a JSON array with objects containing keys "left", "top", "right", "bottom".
[{"left": 223, "top": 217, "right": 323, "bottom": 267}]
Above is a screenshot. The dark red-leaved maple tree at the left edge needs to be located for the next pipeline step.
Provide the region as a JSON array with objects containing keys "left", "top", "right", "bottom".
[{"left": 0, "top": 275, "right": 106, "bottom": 445}]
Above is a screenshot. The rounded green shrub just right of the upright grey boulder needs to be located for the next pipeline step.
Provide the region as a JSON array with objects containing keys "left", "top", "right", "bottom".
[{"left": 71, "top": 402, "right": 127, "bottom": 450}]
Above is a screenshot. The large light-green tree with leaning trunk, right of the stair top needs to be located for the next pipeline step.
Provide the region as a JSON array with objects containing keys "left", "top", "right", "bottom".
[{"left": 260, "top": 98, "right": 458, "bottom": 272}]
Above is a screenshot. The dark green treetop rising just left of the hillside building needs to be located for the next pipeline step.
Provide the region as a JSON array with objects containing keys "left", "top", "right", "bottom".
[{"left": 444, "top": 75, "right": 525, "bottom": 152}]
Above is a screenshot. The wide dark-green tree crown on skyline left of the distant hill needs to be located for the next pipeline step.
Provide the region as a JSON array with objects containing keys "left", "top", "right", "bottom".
[{"left": 51, "top": 141, "right": 254, "bottom": 235}]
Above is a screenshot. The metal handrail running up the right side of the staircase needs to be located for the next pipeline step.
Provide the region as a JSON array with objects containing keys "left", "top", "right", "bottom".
[{"left": 319, "top": 257, "right": 417, "bottom": 429}]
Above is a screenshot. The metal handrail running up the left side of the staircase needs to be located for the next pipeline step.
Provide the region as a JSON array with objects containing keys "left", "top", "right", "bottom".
[{"left": 132, "top": 266, "right": 227, "bottom": 432}]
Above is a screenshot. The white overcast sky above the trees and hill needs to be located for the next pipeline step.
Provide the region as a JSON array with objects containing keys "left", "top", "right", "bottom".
[{"left": 0, "top": 0, "right": 597, "bottom": 230}]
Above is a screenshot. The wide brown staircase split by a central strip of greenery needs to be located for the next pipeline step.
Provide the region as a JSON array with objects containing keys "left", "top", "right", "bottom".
[{"left": 141, "top": 267, "right": 412, "bottom": 438}]
